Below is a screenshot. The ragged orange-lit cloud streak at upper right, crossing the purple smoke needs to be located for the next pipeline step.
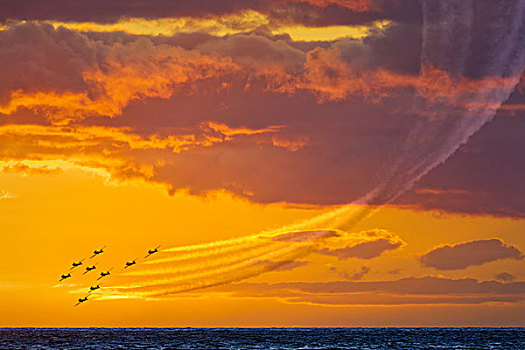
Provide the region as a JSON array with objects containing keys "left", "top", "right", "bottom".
[{"left": 292, "top": 47, "right": 516, "bottom": 106}]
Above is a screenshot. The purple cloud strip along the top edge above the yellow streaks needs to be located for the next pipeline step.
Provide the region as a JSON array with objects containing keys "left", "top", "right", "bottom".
[{"left": 0, "top": 0, "right": 421, "bottom": 26}]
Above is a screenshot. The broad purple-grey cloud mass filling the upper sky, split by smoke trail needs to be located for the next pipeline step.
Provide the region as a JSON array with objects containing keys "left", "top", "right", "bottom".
[{"left": 0, "top": 19, "right": 525, "bottom": 219}]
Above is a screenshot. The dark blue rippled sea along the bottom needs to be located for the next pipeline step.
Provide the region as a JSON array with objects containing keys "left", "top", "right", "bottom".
[{"left": 0, "top": 328, "right": 525, "bottom": 349}]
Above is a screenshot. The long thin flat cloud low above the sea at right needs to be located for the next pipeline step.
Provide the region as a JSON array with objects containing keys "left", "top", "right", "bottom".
[{"left": 207, "top": 276, "right": 525, "bottom": 306}]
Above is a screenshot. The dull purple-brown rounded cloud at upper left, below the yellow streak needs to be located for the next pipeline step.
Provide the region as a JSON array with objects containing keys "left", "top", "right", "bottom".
[{"left": 0, "top": 23, "right": 105, "bottom": 104}]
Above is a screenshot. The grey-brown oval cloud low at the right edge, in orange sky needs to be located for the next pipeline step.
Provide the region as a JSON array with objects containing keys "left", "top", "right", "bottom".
[{"left": 419, "top": 239, "right": 524, "bottom": 270}]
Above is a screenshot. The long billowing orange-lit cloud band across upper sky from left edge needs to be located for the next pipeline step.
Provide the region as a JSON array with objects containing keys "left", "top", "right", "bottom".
[{"left": 0, "top": 23, "right": 506, "bottom": 124}]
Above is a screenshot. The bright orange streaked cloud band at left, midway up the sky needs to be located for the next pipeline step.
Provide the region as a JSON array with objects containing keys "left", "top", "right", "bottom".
[{"left": 0, "top": 122, "right": 294, "bottom": 188}]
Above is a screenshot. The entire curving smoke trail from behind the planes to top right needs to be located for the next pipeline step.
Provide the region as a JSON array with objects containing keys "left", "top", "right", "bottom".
[{"left": 96, "top": 0, "right": 525, "bottom": 297}]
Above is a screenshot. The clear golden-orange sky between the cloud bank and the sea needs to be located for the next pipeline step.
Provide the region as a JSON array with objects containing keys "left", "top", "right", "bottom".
[{"left": 0, "top": 169, "right": 525, "bottom": 327}]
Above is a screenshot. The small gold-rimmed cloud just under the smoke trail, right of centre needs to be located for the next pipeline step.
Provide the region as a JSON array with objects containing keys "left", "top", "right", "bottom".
[{"left": 321, "top": 229, "right": 406, "bottom": 258}]
